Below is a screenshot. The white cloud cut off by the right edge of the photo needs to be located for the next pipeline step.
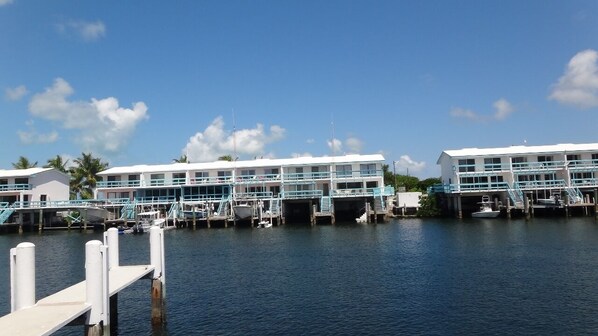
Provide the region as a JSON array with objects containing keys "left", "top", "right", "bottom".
[{"left": 548, "top": 49, "right": 598, "bottom": 109}]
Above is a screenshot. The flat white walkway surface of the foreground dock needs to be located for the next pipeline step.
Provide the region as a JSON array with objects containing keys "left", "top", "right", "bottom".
[{"left": 0, "top": 265, "right": 154, "bottom": 336}]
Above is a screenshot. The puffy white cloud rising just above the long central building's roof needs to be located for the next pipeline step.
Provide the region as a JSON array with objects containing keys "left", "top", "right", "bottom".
[{"left": 183, "top": 116, "right": 286, "bottom": 162}]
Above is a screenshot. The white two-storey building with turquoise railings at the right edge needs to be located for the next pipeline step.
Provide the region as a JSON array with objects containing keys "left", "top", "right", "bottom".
[{"left": 437, "top": 143, "right": 598, "bottom": 207}]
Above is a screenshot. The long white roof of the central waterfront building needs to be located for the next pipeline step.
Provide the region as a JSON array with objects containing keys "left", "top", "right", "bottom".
[{"left": 98, "top": 154, "right": 384, "bottom": 175}]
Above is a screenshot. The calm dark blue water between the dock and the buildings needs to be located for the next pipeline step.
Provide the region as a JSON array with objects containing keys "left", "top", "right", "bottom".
[{"left": 0, "top": 218, "right": 598, "bottom": 335}]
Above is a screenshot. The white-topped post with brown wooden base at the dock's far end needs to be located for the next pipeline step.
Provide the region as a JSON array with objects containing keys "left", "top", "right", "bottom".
[{"left": 150, "top": 226, "right": 166, "bottom": 325}]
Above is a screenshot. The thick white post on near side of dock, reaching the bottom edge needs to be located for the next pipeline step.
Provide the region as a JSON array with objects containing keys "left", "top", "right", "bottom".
[{"left": 85, "top": 240, "right": 110, "bottom": 336}]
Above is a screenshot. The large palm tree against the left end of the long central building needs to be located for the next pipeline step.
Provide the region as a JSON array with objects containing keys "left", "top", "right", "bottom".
[{"left": 70, "top": 153, "right": 108, "bottom": 199}]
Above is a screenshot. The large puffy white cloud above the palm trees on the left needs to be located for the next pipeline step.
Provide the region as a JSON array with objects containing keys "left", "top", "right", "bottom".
[{"left": 29, "top": 78, "right": 148, "bottom": 152}]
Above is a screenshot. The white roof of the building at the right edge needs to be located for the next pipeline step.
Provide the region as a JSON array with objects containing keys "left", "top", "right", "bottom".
[{"left": 438, "top": 143, "right": 598, "bottom": 161}]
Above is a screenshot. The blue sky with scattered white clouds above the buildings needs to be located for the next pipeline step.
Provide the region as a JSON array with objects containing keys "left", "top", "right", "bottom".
[{"left": 0, "top": 0, "right": 598, "bottom": 178}]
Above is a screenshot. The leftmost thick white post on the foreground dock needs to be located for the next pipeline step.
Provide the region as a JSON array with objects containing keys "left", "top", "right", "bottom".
[{"left": 10, "top": 243, "right": 35, "bottom": 312}]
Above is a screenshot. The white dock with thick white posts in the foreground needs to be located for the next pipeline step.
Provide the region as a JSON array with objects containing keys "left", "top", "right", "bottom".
[{"left": 0, "top": 227, "right": 165, "bottom": 336}]
